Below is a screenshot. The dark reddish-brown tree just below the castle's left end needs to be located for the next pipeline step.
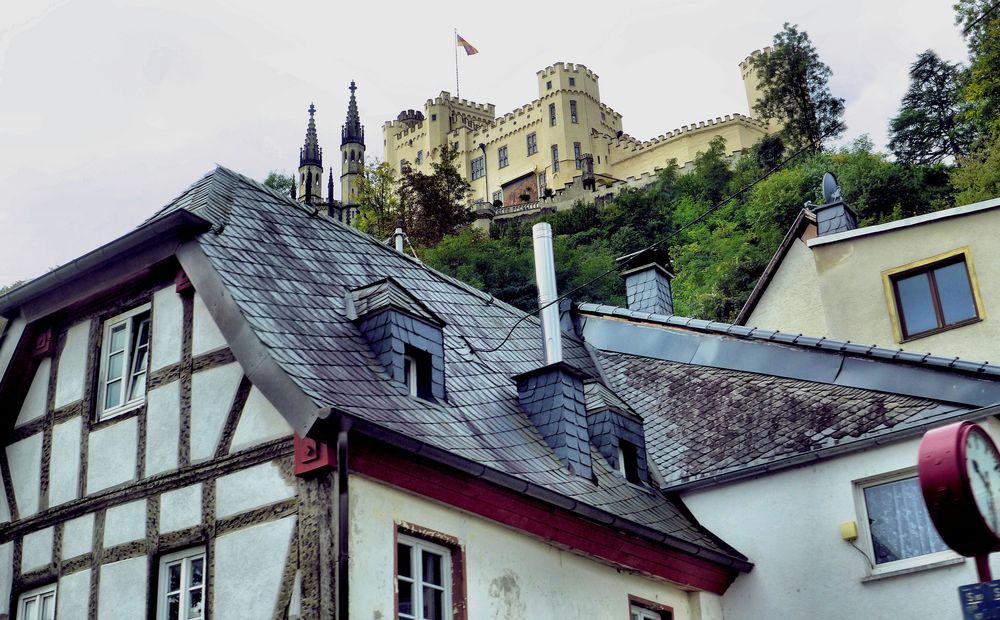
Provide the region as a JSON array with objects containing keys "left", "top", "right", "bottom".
[{"left": 400, "top": 146, "right": 470, "bottom": 246}]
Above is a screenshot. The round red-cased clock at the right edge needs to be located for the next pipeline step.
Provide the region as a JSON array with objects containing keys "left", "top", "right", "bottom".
[{"left": 917, "top": 422, "right": 1000, "bottom": 557}]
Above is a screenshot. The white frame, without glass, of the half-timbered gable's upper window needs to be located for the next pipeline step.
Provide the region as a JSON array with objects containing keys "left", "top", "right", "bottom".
[{"left": 97, "top": 304, "right": 153, "bottom": 420}]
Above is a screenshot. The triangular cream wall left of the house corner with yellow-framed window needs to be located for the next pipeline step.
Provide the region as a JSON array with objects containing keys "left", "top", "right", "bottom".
[{"left": 746, "top": 239, "right": 828, "bottom": 336}]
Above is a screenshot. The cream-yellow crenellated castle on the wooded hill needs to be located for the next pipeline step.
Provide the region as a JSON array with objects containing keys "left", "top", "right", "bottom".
[{"left": 382, "top": 49, "right": 776, "bottom": 216}]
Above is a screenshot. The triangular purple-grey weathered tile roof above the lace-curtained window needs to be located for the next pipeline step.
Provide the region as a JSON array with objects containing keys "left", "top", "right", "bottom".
[{"left": 597, "top": 351, "right": 970, "bottom": 487}]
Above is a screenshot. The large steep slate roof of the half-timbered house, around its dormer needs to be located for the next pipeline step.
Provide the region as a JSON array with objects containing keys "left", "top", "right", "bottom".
[{"left": 154, "top": 167, "right": 743, "bottom": 559}]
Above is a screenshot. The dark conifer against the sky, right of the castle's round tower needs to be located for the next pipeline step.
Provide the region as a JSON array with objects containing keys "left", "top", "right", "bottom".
[{"left": 889, "top": 50, "right": 971, "bottom": 164}]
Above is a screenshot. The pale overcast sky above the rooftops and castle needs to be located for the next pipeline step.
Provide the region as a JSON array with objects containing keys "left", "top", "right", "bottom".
[{"left": 0, "top": 0, "right": 966, "bottom": 285}]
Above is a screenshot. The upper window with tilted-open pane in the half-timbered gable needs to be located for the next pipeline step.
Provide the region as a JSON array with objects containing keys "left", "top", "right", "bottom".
[{"left": 97, "top": 304, "right": 149, "bottom": 419}]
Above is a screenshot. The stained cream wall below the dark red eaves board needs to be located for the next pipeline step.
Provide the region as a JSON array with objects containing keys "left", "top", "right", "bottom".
[{"left": 350, "top": 476, "right": 696, "bottom": 620}]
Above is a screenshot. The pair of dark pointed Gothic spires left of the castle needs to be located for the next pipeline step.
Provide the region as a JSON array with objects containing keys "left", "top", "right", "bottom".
[{"left": 293, "top": 80, "right": 365, "bottom": 224}]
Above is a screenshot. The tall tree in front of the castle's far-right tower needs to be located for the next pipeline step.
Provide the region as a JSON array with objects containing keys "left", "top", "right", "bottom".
[{"left": 752, "top": 23, "right": 845, "bottom": 149}]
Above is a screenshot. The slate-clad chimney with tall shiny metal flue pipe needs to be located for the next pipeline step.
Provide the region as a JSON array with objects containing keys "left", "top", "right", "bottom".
[{"left": 514, "top": 223, "right": 593, "bottom": 478}]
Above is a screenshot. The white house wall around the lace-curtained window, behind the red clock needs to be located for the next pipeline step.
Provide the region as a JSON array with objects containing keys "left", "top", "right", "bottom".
[{"left": 683, "top": 439, "right": 1000, "bottom": 620}]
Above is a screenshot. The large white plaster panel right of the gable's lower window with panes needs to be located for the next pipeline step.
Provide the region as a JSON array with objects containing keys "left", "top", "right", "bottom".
[{"left": 212, "top": 516, "right": 296, "bottom": 620}]
